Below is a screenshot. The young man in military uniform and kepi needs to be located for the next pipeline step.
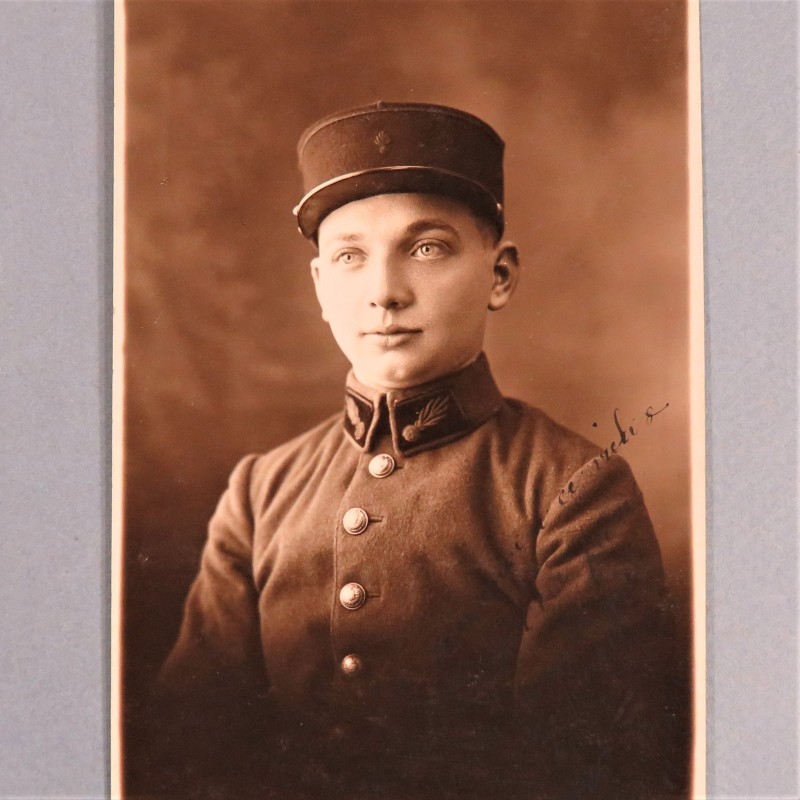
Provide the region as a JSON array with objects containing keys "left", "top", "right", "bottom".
[{"left": 155, "top": 103, "right": 673, "bottom": 800}]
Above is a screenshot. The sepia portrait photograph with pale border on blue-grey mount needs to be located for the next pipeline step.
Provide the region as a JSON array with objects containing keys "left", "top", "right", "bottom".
[{"left": 111, "top": 0, "right": 705, "bottom": 800}]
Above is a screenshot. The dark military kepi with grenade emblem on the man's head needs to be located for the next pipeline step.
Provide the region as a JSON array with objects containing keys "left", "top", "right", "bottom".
[{"left": 294, "top": 102, "right": 503, "bottom": 240}]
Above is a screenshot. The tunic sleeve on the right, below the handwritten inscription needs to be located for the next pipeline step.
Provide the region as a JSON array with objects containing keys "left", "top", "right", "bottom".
[{"left": 515, "top": 456, "right": 678, "bottom": 800}]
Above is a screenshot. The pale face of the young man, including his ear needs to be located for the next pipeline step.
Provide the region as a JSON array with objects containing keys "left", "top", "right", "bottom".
[{"left": 311, "top": 194, "right": 516, "bottom": 390}]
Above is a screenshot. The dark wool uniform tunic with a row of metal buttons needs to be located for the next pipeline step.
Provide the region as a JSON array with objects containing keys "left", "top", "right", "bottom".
[{"left": 156, "top": 356, "right": 671, "bottom": 800}]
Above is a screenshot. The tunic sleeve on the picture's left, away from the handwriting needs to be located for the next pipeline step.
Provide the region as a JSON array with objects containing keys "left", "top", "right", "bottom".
[{"left": 142, "top": 456, "right": 268, "bottom": 798}]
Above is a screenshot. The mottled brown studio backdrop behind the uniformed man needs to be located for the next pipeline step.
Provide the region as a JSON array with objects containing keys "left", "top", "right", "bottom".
[{"left": 122, "top": 0, "right": 690, "bottom": 768}]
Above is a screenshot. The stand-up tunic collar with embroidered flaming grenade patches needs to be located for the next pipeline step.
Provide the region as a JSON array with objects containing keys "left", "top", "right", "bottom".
[{"left": 344, "top": 353, "right": 503, "bottom": 456}]
